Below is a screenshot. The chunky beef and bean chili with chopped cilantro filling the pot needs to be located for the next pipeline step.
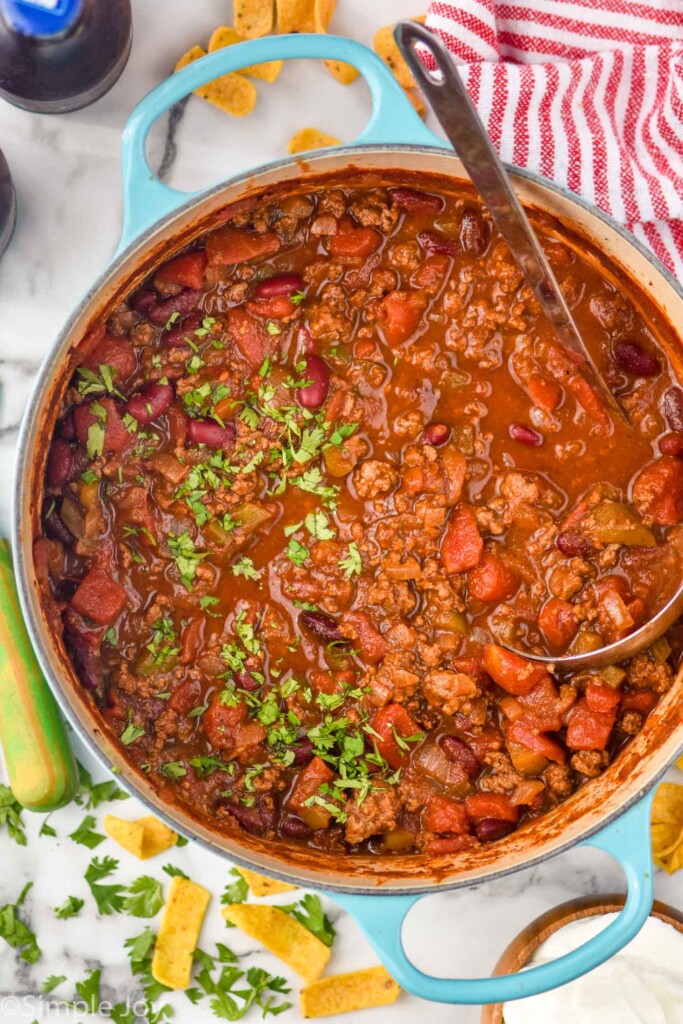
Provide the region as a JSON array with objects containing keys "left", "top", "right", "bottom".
[{"left": 35, "top": 174, "right": 683, "bottom": 856}]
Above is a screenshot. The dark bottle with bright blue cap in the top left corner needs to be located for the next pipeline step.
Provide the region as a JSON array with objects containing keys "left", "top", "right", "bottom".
[{"left": 0, "top": 0, "right": 132, "bottom": 114}]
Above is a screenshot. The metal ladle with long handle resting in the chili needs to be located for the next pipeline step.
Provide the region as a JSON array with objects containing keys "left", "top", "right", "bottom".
[{"left": 394, "top": 22, "right": 683, "bottom": 672}]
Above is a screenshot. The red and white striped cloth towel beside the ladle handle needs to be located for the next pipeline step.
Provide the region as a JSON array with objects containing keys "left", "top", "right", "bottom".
[{"left": 427, "top": 0, "right": 683, "bottom": 282}]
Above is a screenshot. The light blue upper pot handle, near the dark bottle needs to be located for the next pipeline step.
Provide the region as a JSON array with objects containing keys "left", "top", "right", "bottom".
[{"left": 119, "top": 33, "right": 444, "bottom": 251}]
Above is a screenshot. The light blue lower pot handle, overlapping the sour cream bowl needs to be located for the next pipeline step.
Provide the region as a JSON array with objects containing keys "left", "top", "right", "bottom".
[{"left": 328, "top": 792, "right": 654, "bottom": 1005}]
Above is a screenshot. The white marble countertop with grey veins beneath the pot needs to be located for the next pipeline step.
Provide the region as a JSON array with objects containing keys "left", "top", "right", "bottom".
[{"left": 0, "top": 0, "right": 683, "bottom": 1024}]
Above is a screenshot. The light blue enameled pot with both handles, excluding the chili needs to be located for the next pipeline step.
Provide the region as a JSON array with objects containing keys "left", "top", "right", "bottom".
[{"left": 13, "top": 35, "right": 683, "bottom": 1004}]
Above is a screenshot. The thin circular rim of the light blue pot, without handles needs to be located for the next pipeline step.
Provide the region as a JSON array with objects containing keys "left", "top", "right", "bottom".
[{"left": 11, "top": 143, "right": 683, "bottom": 896}]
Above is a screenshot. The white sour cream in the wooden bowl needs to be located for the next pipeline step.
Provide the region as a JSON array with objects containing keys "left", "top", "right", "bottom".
[{"left": 503, "top": 913, "right": 683, "bottom": 1024}]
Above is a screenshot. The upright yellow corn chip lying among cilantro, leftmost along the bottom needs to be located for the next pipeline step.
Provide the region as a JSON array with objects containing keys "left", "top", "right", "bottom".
[{"left": 152, "top": 878, "right": 211, "bottom": 988}]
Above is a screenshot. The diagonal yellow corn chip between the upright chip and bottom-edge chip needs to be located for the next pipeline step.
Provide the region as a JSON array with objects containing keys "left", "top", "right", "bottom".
[{"left": 223, "top": 903, "right": 330, "bottom": 982}]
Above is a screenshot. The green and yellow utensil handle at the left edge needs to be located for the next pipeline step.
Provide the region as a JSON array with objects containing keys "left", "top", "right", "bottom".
[{"left": 0, "top": 540, "right": 77, "bottom": 812}]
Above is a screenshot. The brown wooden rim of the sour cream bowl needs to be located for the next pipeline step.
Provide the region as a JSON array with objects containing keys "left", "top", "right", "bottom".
[{"left": 481, "top": 893, "right": 683, "bottom": 1024}]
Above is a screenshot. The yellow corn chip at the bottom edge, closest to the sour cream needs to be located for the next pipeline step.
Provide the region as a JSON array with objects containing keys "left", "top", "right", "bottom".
[{"left": 301, "top": 967, "right": 400, "bottom": 1017}]
